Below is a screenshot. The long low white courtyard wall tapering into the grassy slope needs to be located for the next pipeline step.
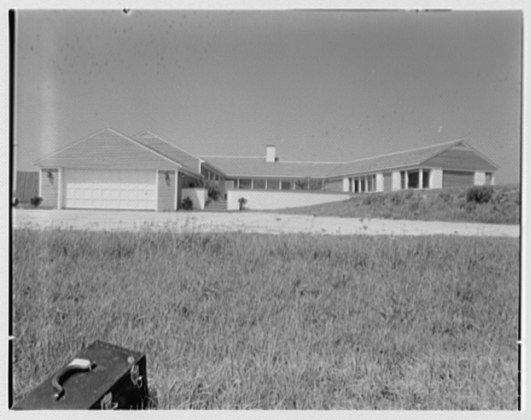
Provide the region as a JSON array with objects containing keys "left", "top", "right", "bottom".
[{"left": 227, "top": 190, "right": 350, "bottom": 210}]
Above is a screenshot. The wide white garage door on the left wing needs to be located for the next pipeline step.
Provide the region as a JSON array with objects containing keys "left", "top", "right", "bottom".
[{"left": 63, "top": 169, "right": 157, "bottom": 210}]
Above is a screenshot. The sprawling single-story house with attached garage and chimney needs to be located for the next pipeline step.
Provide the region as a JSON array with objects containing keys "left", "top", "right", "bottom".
[{"left": 36, "top": 128, "right": 497, "bottom": 211}]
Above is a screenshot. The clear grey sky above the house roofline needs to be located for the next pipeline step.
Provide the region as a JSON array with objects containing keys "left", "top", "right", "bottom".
[{"left": 15, "top": 10, "right": 522, "bottom": 184}]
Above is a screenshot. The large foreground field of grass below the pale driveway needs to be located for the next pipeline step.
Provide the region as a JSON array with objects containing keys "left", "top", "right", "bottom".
[{"left": 13, "top": 229, "right": 519, "bottom": 410}]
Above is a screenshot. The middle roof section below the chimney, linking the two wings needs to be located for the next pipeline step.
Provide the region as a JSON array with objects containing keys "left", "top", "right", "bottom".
[{"left": 202, "top": 156, "right": 337, "bottom": 178}]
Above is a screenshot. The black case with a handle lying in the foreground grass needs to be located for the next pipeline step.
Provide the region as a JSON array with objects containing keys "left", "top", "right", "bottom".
[{"left": 13, "top": 341, "right": 148, "bottom": 410}]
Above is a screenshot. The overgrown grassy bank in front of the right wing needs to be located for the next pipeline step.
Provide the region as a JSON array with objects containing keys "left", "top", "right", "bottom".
[{"left": 277, "top": 185, "right": 520, "bottom": 224}]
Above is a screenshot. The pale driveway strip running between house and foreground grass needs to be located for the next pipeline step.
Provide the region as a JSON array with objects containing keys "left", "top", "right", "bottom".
[{"left": 13, "top": 209, "right": 520, "bottom": 238}]
